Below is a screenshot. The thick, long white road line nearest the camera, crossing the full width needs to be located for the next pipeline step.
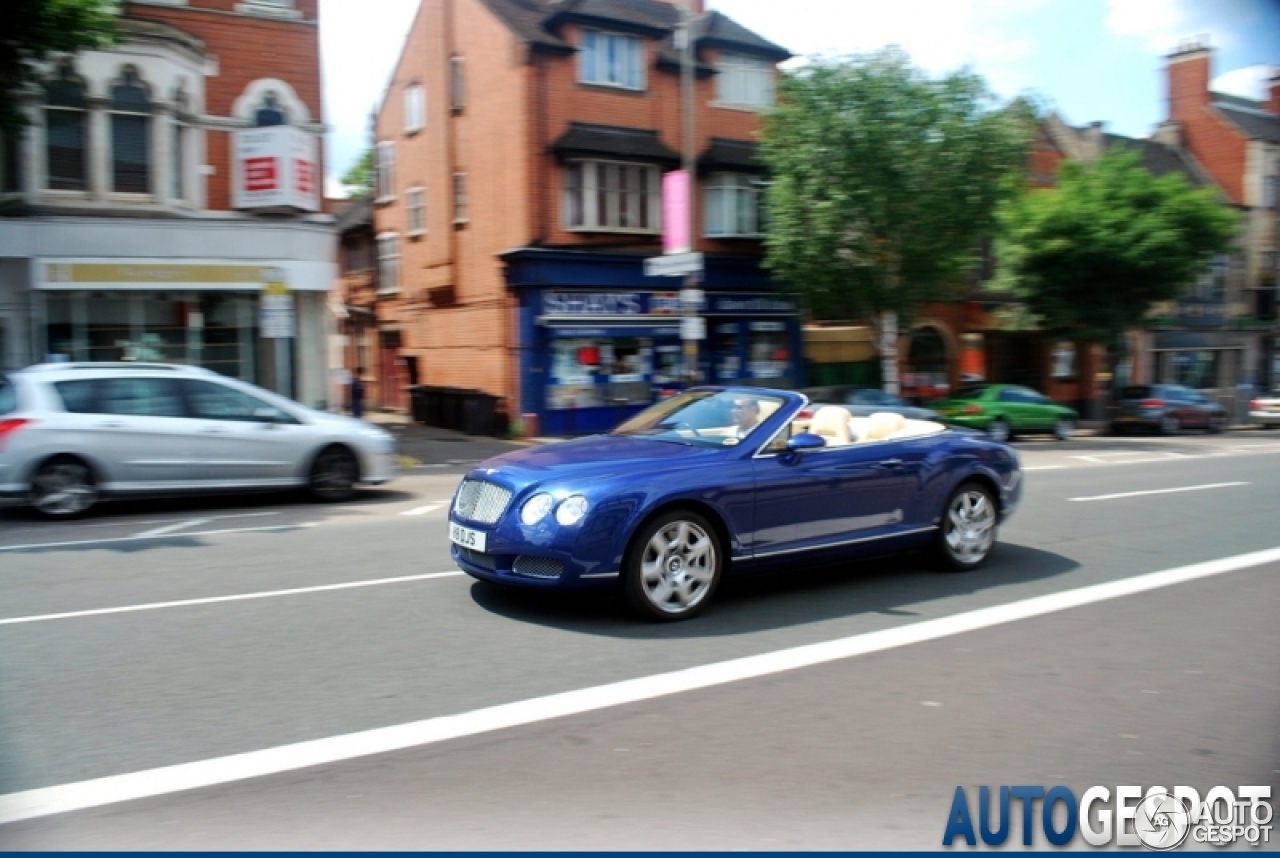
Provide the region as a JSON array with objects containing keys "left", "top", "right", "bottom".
[{"left": 0, "top": 548, "right": 1280, "bottom": 823}]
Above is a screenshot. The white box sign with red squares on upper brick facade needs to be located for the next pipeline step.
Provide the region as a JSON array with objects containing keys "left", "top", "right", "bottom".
[{"left": 232, "top": 125, "right": 320, "bottom": 211}]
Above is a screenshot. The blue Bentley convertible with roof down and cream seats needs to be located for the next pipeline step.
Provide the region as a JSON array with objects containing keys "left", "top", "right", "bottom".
[{"left": 449, "top": 387, "right": 1021, "bottom": 620}]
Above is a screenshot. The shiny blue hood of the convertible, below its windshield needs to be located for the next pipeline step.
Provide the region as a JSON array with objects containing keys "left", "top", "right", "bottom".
[{"left": 474, "top": 435, "right": 727, "bottom": 483}]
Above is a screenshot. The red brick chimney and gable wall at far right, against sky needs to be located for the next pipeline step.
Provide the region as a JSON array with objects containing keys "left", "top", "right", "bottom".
[{"left": 1166, "top": 50, "right": 1248, "bottom": 205}]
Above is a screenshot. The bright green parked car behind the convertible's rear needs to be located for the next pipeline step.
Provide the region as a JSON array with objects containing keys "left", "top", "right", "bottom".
[{"left": 929, "top": 384, "right": 1078, "bottom": 441}]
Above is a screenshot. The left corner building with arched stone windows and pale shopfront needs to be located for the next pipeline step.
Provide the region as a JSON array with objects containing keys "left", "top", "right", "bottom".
[{"left": 0, "top": 0, "right": 334, "bottom": 405}]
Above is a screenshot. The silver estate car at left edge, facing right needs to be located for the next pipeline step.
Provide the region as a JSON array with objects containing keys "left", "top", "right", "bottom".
[{"left": 0, "top": 362, "right": 396, "bottom": 519}]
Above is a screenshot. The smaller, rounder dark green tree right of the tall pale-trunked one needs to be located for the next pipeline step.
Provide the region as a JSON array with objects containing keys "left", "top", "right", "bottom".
[{"left": 998, "top": 147, "right": 1239, "bottom": 366}]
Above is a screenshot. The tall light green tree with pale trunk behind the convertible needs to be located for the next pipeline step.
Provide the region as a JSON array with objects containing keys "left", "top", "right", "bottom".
[{"left": 760, "top": 47, "right": 1029, "bottom": 389}]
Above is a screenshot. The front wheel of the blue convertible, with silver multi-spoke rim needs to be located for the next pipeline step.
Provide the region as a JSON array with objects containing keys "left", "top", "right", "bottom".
[{"left": 622, "top": 510, "right": 724, "bottom": 622}]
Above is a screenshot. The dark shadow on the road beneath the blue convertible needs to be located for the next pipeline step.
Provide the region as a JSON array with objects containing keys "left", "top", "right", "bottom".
[{"left": 471, "top": 543, "right": 1080, "bottom": 640}]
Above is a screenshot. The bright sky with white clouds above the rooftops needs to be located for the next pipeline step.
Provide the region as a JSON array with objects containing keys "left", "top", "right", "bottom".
[{"left": 320, "top": 0, "right": 1280, "bottom": 196}]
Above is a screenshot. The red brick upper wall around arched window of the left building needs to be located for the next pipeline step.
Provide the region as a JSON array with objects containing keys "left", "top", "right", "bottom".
[{"left": 125, "top": 0, "right": 324, "bottom": 210}]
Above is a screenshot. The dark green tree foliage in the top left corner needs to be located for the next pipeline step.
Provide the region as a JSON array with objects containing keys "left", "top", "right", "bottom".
[{"left": 0, "top": 0, "right": 119, "bottom": 132}]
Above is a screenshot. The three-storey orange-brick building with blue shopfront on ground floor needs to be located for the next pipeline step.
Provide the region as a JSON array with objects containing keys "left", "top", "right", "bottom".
[{"left": 374, "top": 0, "right": 800, "bottom": 433}]
